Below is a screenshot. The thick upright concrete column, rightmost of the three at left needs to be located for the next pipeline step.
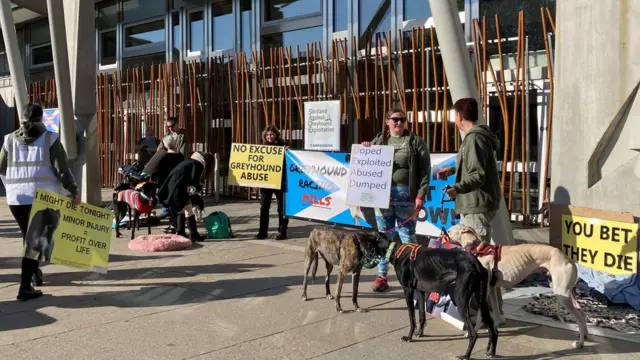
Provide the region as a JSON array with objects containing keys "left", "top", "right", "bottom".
[{"left": 62, "top": 0, "right": 102, "bottom": 205}]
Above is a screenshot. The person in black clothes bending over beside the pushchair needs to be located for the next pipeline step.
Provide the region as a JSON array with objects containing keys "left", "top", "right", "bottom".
[{"left": 158, "top": 152, "right": 213, "bottom": 241}]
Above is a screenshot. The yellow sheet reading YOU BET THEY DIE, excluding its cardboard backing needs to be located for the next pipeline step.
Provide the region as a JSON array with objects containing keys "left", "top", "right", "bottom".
[{"left": 562, "top": 215, "right": 638, "bottom": 275}]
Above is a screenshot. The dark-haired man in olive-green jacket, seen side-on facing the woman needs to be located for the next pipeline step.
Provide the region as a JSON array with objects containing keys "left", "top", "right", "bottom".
[{"left": 437, "top": 98, "right": 502, "bottom": 244}]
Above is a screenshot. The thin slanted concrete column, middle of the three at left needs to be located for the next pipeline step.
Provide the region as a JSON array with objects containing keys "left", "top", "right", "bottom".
[{"left": 47, "top": 0, "right": 77, "bottom": 160}]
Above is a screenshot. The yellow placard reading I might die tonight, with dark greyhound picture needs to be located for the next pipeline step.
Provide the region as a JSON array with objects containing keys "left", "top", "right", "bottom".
[{"left": 25, "top": 189, "right": 113, "bottom": 273}]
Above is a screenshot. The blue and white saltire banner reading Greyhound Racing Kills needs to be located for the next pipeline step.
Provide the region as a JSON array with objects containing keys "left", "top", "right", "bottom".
[{"left": 285, "top": 150, "right": 459, "bottom": 237}]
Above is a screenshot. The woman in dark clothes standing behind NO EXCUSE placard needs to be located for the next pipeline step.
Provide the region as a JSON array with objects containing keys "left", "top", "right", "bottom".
[{"left": 254, "top": 125, "right": 289, "bottom": 240}]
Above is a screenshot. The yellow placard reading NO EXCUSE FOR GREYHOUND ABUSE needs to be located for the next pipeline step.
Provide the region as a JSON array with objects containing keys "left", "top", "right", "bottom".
[{"left": 229, "top": 143, "right": 284, "bottom": 190}]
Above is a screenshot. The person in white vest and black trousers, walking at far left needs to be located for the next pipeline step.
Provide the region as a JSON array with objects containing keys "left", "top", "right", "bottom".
[{"left": 0, "top": 104, "right": 80, "bottom": 300}]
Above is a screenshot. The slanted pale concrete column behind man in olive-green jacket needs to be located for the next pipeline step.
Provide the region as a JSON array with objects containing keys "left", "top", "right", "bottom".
[{"left": 429, "top": 0, "right": 514, "bottom": 245}]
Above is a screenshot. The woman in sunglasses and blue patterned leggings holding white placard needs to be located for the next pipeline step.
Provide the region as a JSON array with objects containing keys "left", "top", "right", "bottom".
[{"left": 362, "top": 109, "right": 431, "bottom": 292}]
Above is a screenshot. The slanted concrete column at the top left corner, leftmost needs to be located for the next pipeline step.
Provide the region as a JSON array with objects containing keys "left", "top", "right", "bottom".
[{"left": 0, "top": 0, "right": 29, "bottom": 116}]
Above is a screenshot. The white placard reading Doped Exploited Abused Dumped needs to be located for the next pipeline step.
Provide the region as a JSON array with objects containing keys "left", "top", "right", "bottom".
[{"left": 347, "top": 144, "right": 394, "bottom": 209}]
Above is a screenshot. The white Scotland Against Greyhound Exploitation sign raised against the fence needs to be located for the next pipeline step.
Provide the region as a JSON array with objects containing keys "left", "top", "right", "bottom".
[{"left": 304, "top": 100, "right": 340, "bottom": 151}]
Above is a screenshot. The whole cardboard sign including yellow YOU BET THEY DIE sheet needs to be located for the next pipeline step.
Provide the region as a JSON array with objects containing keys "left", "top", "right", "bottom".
[{"left": 549, "top": 203, "right": 639, "bottom": 275}]
